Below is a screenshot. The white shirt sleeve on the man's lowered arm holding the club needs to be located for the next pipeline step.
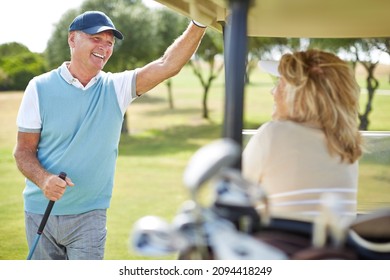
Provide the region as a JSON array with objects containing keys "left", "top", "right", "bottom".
[{"left": 16, "top": 79, "right": 42, "bottom": 132}]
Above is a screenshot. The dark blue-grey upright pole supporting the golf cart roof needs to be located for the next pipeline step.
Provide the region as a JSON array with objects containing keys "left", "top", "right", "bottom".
[{"left": 223, "top": 0, "right": 251, "bottom": 169}]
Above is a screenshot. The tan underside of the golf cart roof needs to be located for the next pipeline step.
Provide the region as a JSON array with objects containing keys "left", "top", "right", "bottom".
[{"left": 157, "top": 0, "right": 390, "bottom": 38}]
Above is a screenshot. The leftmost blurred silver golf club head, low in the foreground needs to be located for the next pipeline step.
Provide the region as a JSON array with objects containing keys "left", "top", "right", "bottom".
[{"left": 131, "top": 216, "right": 185, "bottom": 256}]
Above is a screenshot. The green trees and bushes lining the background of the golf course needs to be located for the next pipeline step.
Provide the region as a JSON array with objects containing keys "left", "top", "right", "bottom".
[{"left": 0, "top": 0, "right": 390, "bottom": 130}]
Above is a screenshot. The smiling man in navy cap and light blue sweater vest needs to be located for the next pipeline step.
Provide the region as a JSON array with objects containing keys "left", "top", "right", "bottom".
[{"left": 14, "top": 11, "right": 205, "bottom": 260}]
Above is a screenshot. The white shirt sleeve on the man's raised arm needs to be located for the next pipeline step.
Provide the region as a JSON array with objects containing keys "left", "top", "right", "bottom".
[{"left": 112, "top": 70, "right": 138, "bottom": 114}]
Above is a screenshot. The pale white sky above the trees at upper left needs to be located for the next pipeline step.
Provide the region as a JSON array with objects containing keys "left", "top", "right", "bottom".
[{"left": 0, "top": 0, "right": 161, "bottom": 53}]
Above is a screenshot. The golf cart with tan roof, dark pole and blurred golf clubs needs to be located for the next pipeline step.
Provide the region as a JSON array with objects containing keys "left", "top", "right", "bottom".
[{"left": 131, "top": 0, "right": 390, "bottom": 259}]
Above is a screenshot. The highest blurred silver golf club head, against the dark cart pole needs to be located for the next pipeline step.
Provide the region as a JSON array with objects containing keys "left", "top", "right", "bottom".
[{"left": 183, "top": 138, "right": 241, "bottom": 192}]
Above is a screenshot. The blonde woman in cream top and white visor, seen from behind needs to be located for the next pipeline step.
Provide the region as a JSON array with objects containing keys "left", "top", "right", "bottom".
[{"left": 242, "top": 50, "right": 362, "bottom": 219}]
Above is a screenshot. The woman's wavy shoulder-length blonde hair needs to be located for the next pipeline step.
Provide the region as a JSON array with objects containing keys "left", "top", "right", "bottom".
[{"left": 279, "top": 50, "right": 362, "bottom": 163}]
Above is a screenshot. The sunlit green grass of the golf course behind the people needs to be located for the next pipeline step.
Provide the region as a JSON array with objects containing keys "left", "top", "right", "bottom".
[{"left": 0, "top": 65, "right": 390, "bottom": 260}]
